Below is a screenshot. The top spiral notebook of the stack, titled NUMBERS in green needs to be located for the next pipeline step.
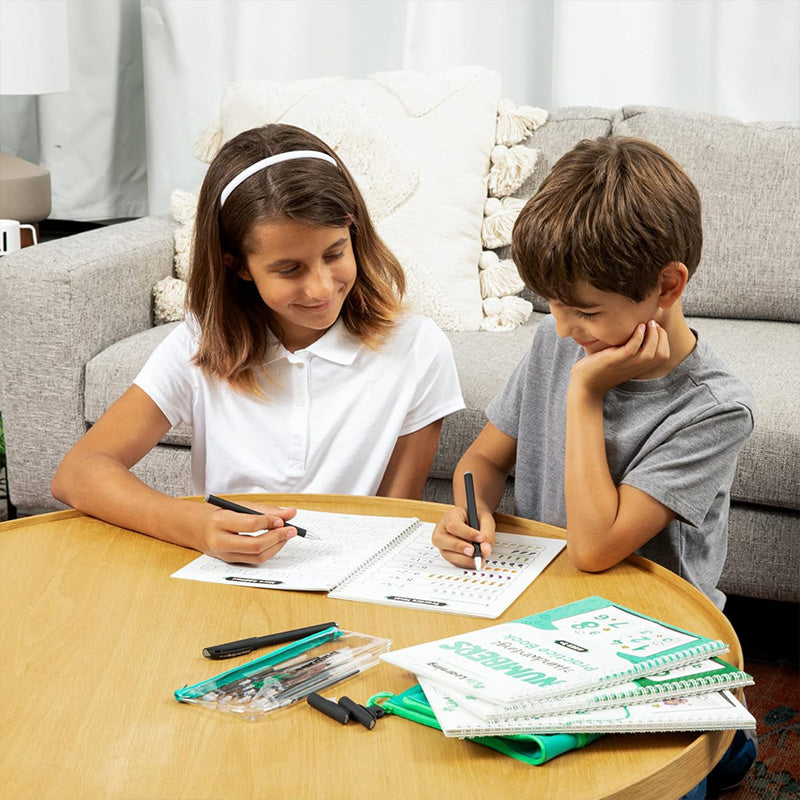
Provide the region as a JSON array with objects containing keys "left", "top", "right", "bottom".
[{"left": 381, "top": 597, "right": 728, "bottom": 704}]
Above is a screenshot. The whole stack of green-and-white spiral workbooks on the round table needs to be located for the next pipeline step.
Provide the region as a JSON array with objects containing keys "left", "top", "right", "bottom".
[{"left": 381, "top": 597, "right": 756, "bottom": 737}]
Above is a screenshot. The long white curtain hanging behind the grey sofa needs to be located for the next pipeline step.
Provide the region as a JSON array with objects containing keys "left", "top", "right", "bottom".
[{"left": 0, "top": 0, "right": 800, "bottom": 220}]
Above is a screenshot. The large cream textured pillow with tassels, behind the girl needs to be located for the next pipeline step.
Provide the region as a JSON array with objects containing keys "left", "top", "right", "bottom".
[{"left": 154, "top": 67, "right": 547, "bottom": 330}]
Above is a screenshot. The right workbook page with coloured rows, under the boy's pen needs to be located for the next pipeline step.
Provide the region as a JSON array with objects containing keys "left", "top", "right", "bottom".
[{"left": 331, "top": 522, "right": 566, "bottom": 619}]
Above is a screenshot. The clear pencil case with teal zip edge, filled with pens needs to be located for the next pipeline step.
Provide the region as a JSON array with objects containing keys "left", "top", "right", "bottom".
[{"left": 175, "top": 627, "right": 391, "bottom": 720}]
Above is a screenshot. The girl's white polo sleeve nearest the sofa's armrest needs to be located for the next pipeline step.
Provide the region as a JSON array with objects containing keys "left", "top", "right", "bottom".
[{"left": 133, "top": 322, "right": 197, "bottom": 427}]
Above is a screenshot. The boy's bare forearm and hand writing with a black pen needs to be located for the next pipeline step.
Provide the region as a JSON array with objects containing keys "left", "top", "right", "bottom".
[{"left": 432, "top": 422, "right": 517, "bottom": 569}]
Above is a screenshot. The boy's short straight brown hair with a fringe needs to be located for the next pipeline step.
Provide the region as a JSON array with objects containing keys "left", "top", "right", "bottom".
[{"left": 512, "top": 136, "right": 703, "bottom": 306}]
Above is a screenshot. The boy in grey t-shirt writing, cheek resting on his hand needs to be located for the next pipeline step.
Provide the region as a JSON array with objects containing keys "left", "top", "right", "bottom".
[{"left": 433, "top": 137, "right": 756, "bottom": 797}]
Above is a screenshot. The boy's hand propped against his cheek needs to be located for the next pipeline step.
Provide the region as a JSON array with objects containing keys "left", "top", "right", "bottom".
[{"left": 571, "top": 320, "right": 669, "bottom": 396}]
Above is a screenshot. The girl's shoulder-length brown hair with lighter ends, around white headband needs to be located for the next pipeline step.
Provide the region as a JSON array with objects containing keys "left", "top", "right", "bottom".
[{"left": 186, "top": 125, "right": 405, "bottom": 394}]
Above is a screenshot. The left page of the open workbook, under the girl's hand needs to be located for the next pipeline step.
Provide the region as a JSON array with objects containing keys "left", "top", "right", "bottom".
[{"left": 172, "top": 510, "right": 417, "bottom": 591}]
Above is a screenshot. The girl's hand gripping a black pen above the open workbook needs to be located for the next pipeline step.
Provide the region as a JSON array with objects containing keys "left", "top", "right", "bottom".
[{"left": 200, "top": 505, "right": 297, "bottom": 564}]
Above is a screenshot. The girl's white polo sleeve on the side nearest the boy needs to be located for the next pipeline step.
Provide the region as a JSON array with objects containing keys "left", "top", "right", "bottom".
[{"left": 400, "top": 319, "right": 464, "bottom": 436}]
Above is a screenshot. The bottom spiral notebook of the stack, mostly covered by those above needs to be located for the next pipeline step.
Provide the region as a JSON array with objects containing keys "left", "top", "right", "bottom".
[{"left": 420, "top": 679, "right": 756, "bottom": 738}]
